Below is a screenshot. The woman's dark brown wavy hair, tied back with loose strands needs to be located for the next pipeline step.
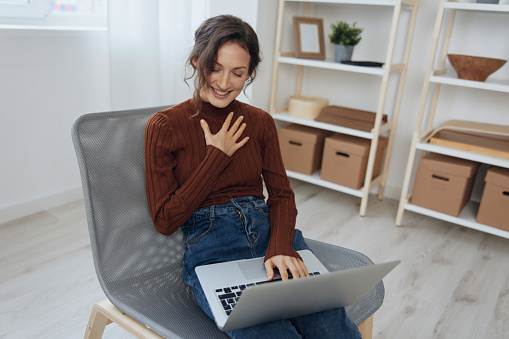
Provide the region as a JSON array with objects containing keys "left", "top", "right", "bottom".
[{"left": 185, "top": 15, "right": 261, "bottom": 112}]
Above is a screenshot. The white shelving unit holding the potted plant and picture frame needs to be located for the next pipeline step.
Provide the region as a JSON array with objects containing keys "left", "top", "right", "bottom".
[{"left": 270, "top": 0, "right": 419, "bottom": 215}]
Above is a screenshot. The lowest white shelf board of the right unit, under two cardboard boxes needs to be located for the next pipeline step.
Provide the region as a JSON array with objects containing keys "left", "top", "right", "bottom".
[{"left": 404, "top": 201, "right": 509, "bottom": 239}]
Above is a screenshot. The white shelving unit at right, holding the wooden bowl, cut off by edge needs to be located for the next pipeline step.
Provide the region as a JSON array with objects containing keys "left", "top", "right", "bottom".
[{"left": 396, "top": 0, "right": 509, "bottom": 239}]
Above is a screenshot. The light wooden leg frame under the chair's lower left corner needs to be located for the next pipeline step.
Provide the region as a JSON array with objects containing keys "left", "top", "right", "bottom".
[{"left": 84, "top": 299, "right": 163, "bottom": 339}]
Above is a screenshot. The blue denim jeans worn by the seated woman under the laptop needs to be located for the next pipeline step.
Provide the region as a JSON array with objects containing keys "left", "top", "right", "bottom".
[{"left": 182, "top": 196, "right": 360, "bottom": 339}]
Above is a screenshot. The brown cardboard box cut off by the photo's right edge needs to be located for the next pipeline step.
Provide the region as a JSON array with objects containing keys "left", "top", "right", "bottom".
[{"left": 477, "top": 167, "right": 509, "bottom": 231}]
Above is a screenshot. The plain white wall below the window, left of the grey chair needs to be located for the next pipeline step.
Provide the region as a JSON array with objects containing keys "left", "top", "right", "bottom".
[{"left": 0, "top": 30, "right": 110, "bottom": 222}]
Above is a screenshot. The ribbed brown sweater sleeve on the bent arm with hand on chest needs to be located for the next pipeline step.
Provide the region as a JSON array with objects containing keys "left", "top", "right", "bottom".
[{"left": 145, "top": 113, "right": 231, "bottom": 235}]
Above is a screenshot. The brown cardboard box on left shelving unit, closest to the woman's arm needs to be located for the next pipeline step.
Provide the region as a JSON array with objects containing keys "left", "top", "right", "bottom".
[{"left": 278, "top": 124, "right": 331, "bottom": 174}]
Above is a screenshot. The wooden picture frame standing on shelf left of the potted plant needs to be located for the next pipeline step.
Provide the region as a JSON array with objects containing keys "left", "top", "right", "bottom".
[{"left": 293, "top": 16, "right": 325, "bottom": 60}]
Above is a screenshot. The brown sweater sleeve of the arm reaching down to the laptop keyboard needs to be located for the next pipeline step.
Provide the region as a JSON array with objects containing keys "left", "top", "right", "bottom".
[{"left": 262, "top": 113, "right": 300, "bottom": 260}]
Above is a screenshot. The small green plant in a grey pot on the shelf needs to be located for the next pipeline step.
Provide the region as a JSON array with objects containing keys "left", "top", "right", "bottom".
[{"left": 329, "top": 21, "right": 364, "bottom": 62}]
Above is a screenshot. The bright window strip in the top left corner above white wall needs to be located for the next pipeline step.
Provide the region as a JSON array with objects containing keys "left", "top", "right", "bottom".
[{"left": 0, "top": 0, "right": 108, "bottom": 30}]
